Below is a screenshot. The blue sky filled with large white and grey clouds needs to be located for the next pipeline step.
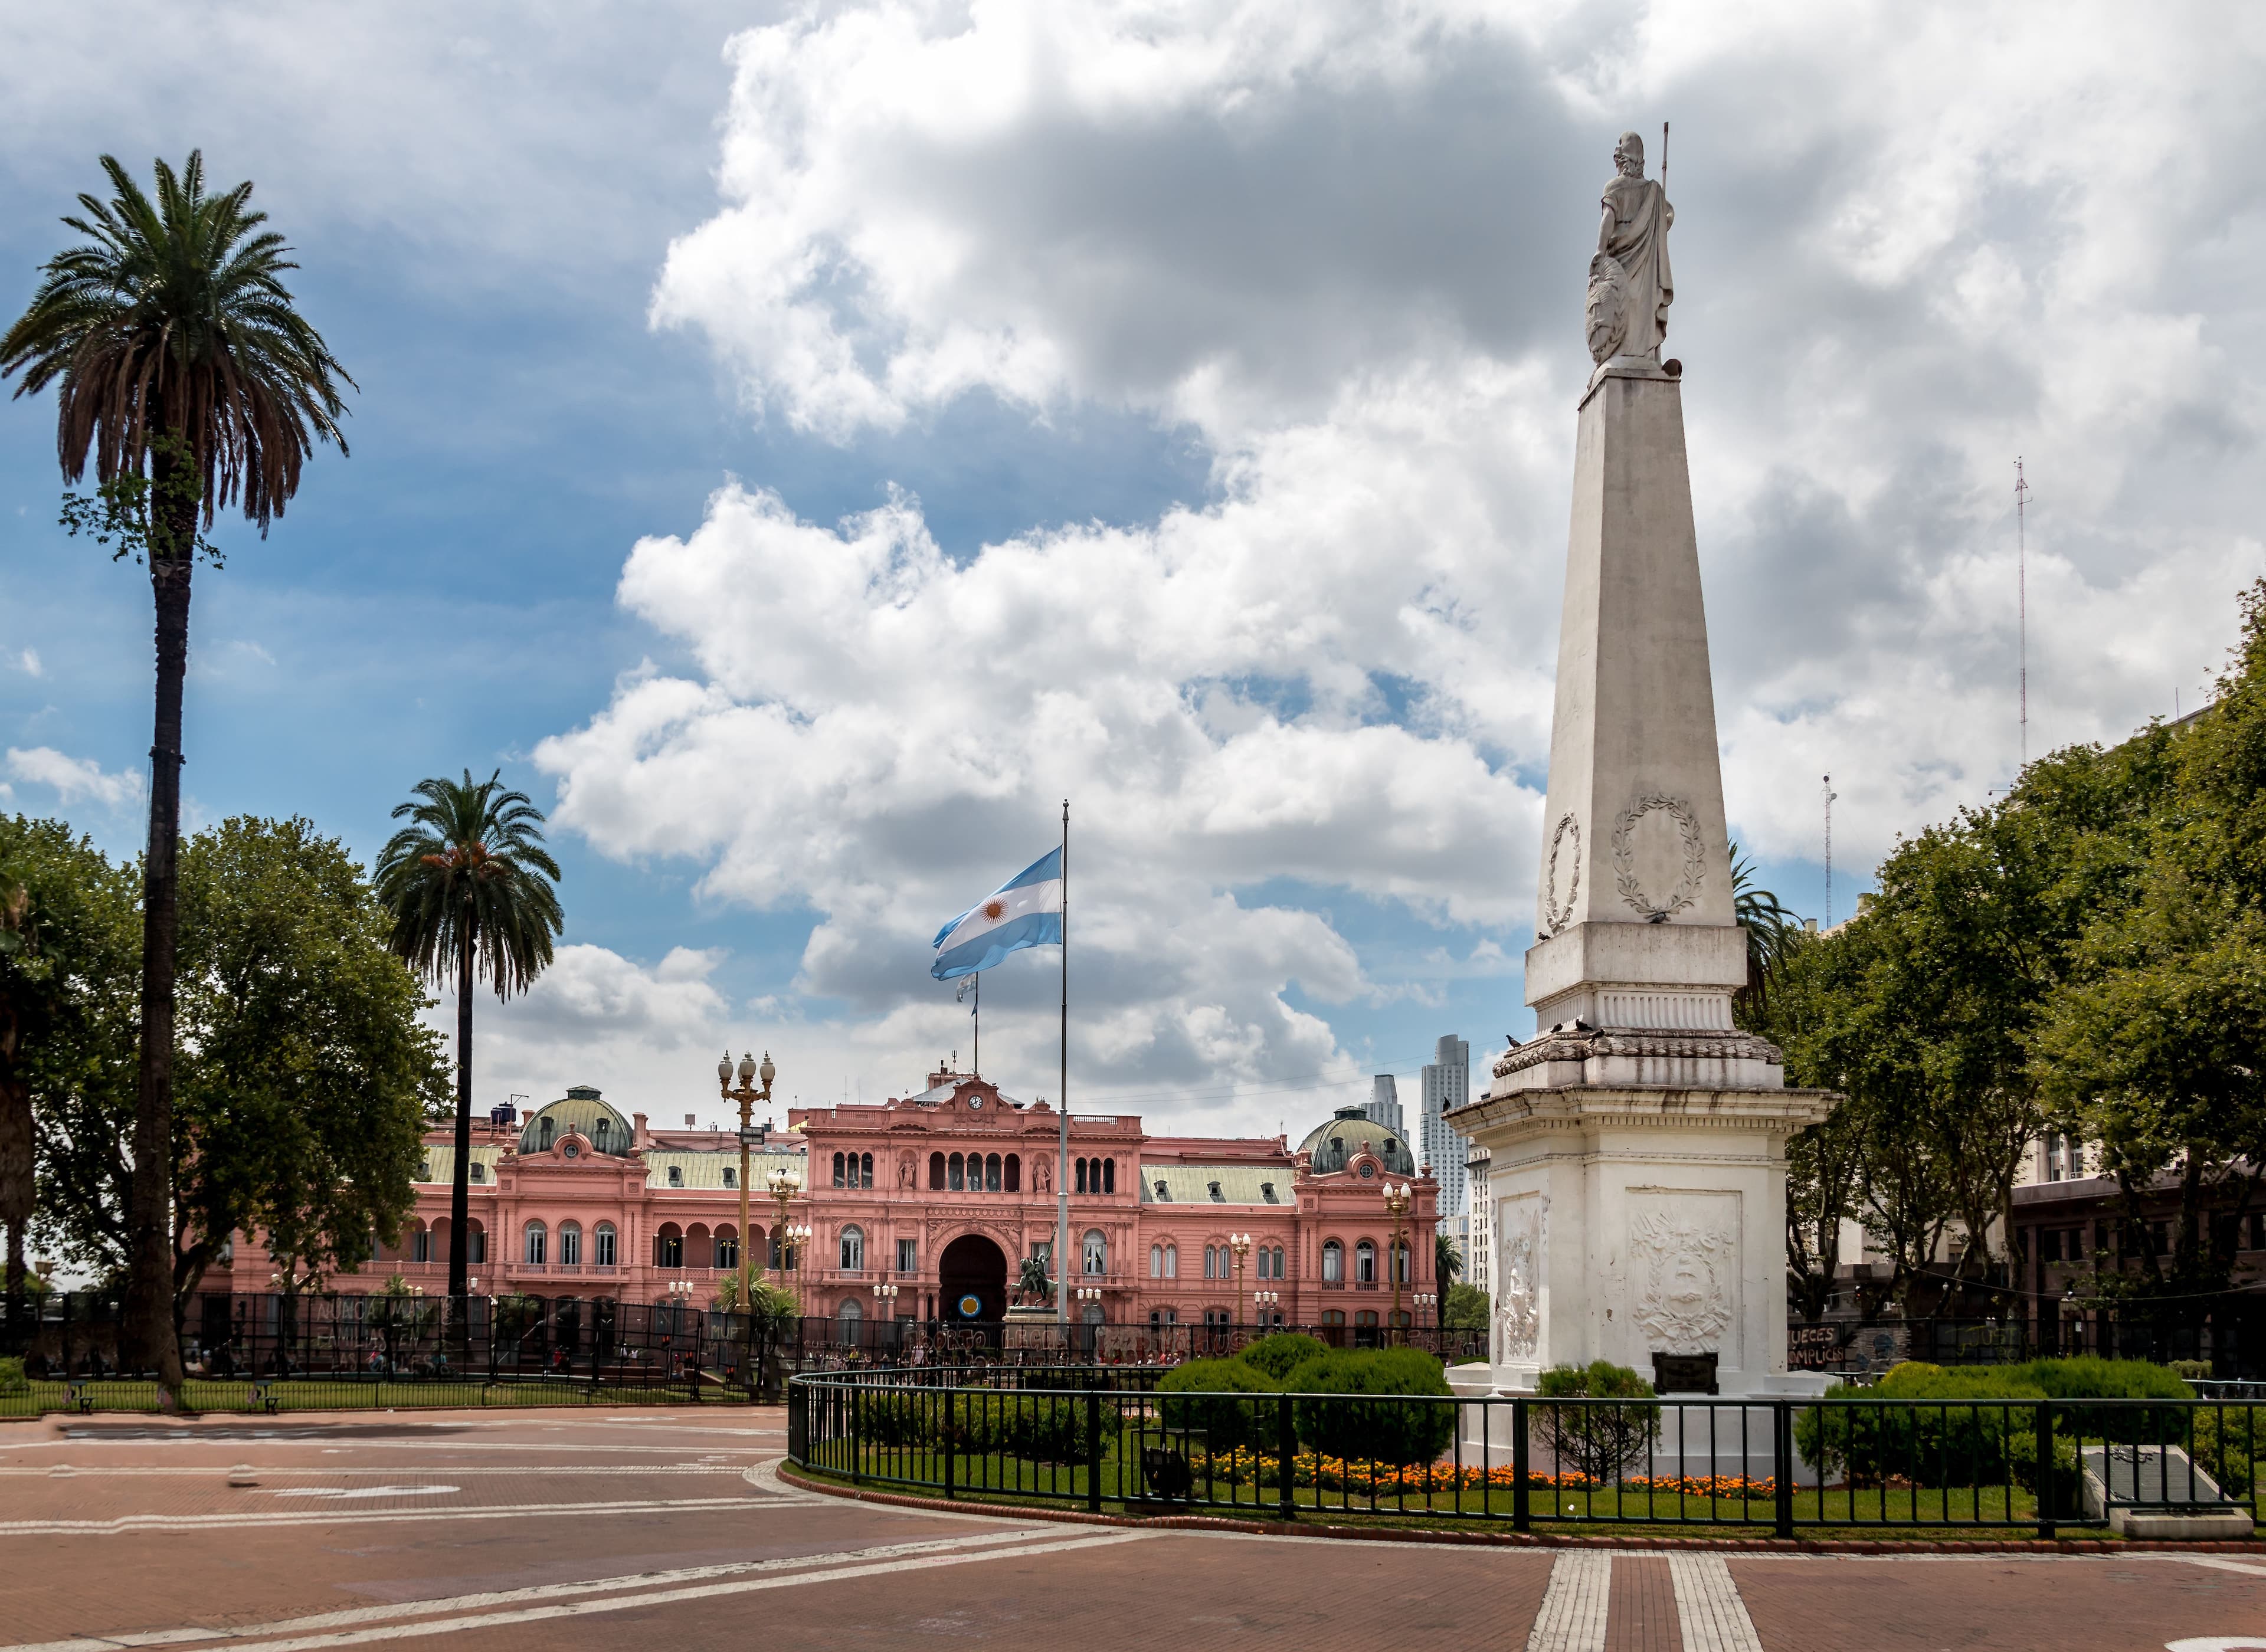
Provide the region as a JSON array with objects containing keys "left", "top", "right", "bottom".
[{"left": 0, "top": 0, "right": 2266, "bottom": 1138}]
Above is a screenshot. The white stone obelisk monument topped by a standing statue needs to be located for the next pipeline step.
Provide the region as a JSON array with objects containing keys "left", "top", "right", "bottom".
[{"left": 1455, "top": 134, "right": 1833, "bottom": 1396}]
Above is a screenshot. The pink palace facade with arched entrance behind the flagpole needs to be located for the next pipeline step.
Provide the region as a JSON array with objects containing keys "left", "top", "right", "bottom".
[{"left": 221, "top": 1070, "right": 1439, "bottom": 1326}]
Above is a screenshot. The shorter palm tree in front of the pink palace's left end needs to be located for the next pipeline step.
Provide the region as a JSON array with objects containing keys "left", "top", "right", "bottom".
[{"left": 378, "top": 768, "right": 562, "bottom": 1301}]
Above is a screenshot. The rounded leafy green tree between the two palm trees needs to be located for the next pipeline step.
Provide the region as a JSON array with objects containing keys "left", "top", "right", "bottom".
[{"left": 41, "top": 818, "right": 446, "bottom": 1317}]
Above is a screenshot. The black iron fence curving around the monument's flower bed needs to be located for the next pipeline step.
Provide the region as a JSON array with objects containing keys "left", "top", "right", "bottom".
[{"left": 788, "top": 1366, "right": 2266, "bottom": 1536}]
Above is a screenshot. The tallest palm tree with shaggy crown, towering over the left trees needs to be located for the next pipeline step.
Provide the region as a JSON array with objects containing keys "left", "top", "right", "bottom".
[{"left": 0, "top": 152, "right": 353, "bottom": 1387}]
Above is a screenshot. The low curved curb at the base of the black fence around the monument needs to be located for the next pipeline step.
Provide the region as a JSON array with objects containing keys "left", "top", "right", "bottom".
[{"left": 777, "top": 1461, "right": 2266, "bottom": 1557}]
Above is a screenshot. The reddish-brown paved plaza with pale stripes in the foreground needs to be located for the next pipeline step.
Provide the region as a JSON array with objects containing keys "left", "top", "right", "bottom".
[{"left": 0, "top": 1410, "right": 2266, "bottom": 1652}]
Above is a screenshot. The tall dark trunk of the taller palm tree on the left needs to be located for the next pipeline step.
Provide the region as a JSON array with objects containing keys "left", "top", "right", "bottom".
[{"left": 120, "top": 548, "right": 195, "bottom": 1391}]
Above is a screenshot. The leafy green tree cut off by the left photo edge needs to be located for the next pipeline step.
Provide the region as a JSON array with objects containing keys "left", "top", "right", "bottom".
[{"left": 0, "top": 816, "right": 138, "bottom": 1323}]
